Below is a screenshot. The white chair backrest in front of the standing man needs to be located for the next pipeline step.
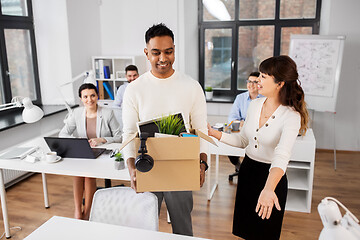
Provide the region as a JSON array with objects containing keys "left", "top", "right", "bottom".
[{"left": 89, "top": 187, "right": 159, "bottom": 231}]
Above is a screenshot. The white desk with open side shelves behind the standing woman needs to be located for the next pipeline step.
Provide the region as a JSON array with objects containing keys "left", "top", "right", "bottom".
[{"left": 206, "top": 129, "right": 316, "bottom": 213}]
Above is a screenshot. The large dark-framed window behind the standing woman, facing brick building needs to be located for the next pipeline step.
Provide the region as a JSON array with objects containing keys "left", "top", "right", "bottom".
[{"left": 199, "top": 0, "right": 321, "bottom": 101}]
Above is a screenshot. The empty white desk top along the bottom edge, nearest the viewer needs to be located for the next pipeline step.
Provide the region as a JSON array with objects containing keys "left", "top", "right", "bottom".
[{"left": 24, "top": 216, "right": 211, "bottom": 240}]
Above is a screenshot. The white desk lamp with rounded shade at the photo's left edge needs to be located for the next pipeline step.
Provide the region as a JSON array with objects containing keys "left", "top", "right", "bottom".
[{"left": 0, "top": 97, "right": 44, "bottom": 123}]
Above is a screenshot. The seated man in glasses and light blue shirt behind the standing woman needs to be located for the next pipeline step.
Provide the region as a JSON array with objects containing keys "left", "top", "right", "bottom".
[{"left": 228, "top": 72, "right": 263, "bottom": 173}]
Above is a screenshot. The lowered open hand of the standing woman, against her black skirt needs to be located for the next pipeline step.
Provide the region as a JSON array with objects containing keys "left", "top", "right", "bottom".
[{"left": 255, "top": 188, "right": 281, "bottom": 219}]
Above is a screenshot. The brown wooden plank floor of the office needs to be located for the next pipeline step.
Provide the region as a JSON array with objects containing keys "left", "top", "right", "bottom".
[{"left": 0, "top": 150, "right": 360, "bottom": 240}]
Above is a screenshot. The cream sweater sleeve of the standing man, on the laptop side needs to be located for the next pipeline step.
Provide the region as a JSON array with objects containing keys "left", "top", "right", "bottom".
[{"left": 122, "top": 85, "right": 139, "bottom": 160}]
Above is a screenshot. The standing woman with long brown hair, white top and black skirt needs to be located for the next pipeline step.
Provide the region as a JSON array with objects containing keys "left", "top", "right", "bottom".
[{"left": 208, "top": 56, "right": 308, "bottom": 240}]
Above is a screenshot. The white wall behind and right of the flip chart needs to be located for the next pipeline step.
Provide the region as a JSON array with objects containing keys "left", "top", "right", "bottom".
[{"left": 313, "top": 0, "right": 360, "bottom": 151}]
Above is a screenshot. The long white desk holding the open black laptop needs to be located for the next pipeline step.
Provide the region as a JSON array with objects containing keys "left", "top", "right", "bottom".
[{"left": 0, "top": 132, "right": 130, "bottom": 238}]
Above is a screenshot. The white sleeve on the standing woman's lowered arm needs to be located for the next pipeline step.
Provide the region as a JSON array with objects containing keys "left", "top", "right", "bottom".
[{"left": 270, "top": 111, "right": 301, "bottom": 174}]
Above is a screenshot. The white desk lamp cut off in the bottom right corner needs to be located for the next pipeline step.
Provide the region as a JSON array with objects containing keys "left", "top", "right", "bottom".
[{"left": 318, "top": 197, "right": 360, "bottom": 240}]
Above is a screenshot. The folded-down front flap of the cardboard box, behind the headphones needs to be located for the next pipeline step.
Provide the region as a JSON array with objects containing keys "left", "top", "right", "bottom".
[{"left": 135, "top": 137, "right": 200, "bottom": 161}]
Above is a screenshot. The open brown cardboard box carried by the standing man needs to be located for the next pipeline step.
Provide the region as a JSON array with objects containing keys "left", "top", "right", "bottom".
[{"left": 120, "top": 131, "right": 216, "bottom": 192}]
